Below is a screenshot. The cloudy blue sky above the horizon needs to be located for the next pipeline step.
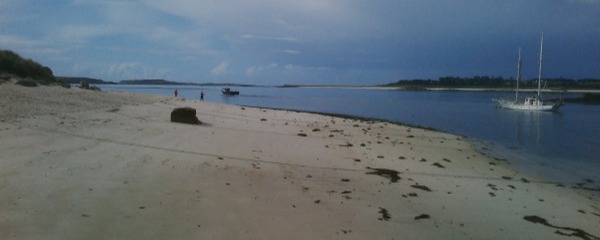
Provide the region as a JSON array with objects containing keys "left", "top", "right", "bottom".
[{"left": 0, "top": 0, "right": 600, "bottom": 85}]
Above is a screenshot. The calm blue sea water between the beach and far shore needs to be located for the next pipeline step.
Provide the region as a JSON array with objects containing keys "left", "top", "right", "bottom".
[{"left": 100, "top": 85, "right": 600, "bottom": 188}]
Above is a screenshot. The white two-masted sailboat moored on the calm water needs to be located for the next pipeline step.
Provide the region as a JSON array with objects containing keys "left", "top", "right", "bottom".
[{"left": 494, "top": 33, "right": 562, "bottom": 111}]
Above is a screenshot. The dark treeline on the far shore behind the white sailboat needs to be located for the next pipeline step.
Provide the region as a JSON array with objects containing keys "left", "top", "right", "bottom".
[{"left": 386, "top": 76, "right": 600, "bottom": 90}]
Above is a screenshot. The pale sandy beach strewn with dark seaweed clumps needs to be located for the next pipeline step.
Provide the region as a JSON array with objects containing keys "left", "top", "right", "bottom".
[{"left": 0, "top": 82, "right": 600, "bottom": 239}]
